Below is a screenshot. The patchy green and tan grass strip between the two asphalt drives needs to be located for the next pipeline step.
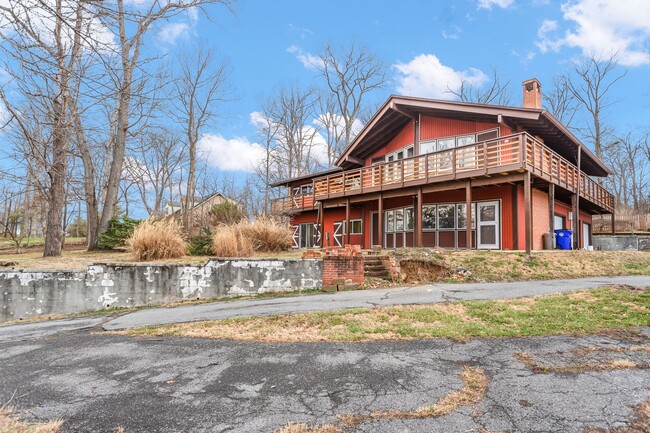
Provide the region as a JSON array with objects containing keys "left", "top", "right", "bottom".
[{"left": 122, "top": 287, "right": 650, "bottom": 342}]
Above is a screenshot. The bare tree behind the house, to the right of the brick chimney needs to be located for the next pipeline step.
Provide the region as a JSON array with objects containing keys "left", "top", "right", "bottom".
[{"left": 563, "top": 54, "right": 627, "bottom": 158}]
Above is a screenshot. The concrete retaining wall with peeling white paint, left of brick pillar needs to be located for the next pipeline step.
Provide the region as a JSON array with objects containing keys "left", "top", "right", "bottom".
[{"left": 0, "top": 259, "right": 323, "bottom": 322}]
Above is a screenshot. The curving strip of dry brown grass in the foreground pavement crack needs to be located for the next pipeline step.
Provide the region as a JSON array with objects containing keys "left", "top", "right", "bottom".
[{"left": 276, "top": 366, "right": 488, "bottom": 433}]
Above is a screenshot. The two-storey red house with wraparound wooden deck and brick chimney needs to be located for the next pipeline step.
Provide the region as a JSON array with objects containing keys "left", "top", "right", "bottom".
[{"left": 274, "top": 79, "right": 614, "bottom": 251}]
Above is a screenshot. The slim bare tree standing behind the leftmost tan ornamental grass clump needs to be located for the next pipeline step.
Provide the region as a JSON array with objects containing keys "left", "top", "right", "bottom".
[{"left": 174, "top": 46, "right": 227, "bottom": 229}]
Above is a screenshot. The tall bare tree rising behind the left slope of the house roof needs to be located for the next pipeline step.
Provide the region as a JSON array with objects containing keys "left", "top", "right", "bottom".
[{"left": 314, "top": 43, "right": 387, "bottom": 145}]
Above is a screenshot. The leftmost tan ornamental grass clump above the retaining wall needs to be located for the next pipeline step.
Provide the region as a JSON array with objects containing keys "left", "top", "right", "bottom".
[{"left": 126, "top": 218, "right": 187, "bottom": 261}]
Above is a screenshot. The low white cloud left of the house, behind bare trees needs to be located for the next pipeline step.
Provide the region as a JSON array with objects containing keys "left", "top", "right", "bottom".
[{"left": 197, "top": 134, "right": 264, "bottom": 172}]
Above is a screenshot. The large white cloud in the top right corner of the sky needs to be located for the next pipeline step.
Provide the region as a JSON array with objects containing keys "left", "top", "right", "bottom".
[{"left": 537, "top": 0, "right": 650, "bottom": 66}]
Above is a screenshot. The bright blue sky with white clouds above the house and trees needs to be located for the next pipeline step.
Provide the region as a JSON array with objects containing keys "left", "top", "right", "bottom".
[{"left": 165, "top": 0, "right": 650, "bottom": 175}]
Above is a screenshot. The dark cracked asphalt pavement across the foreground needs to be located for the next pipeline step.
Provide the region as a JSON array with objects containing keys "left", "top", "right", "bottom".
[{"left": 0, "top": 319, "right": 650, "bottom": 433}]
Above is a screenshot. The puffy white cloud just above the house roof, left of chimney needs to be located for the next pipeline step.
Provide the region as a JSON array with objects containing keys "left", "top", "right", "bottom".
[{"left": 393, "top": 54, "right": 488, "bottom": 99}]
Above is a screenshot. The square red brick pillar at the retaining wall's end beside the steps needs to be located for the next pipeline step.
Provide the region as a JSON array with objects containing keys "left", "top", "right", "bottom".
[{"left": 323, "top": 245, "right": 365, "bottom": 291}]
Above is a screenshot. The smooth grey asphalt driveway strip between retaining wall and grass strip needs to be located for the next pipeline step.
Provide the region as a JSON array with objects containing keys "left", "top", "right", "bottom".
[{"left": 101, "top": 276, "right": 650, "bottom": 330}]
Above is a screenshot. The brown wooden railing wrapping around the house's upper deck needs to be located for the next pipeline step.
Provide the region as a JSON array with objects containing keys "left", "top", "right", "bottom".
[{"left": 272, "top": 133, "right": 614, "bottom": 210}]
